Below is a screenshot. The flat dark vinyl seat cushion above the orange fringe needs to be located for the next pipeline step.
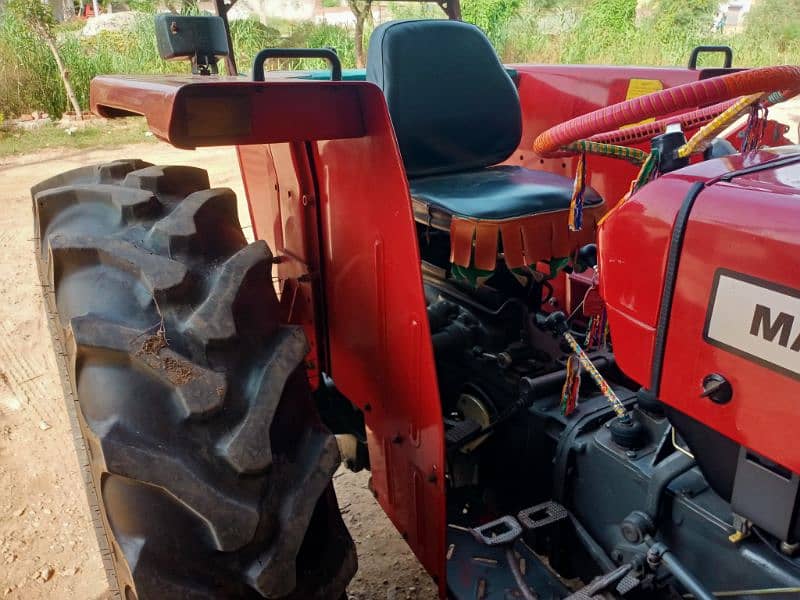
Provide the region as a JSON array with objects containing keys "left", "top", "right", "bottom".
[{"left": 409, "top": 165, "right": 602, "bottom": 228}]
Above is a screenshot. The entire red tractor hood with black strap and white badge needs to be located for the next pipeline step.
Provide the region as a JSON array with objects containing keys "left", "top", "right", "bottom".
[{"left": 599, "top": 146, "right": 800, "bottom": 472}]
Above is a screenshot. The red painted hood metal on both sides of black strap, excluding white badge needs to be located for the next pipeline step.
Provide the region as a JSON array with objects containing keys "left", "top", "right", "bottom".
[{"left": 600, "top": 151, "right": 800, "bottom": 472}]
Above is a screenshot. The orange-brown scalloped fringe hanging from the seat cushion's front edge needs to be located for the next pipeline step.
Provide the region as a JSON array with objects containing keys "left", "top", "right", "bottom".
[{"left": 450, "top": 204, "right": 607, "bottom": 271}]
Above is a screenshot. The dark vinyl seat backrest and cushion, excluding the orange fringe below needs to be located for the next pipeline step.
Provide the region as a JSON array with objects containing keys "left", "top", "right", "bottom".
[{"left": 367, "top": 20, "right": 601, "bottom": 225}]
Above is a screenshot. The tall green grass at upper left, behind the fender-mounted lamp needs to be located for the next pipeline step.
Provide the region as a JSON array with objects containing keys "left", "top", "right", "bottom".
[{"left": 0, "top": 11, "right": 355, "bottom": 118}]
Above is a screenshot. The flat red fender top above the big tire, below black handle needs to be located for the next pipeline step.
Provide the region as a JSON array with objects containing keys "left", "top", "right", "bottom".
[{"left": 90, "top": 76, "right": 363, "bottom": 148}]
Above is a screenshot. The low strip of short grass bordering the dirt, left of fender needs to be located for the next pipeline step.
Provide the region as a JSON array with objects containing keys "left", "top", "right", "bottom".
[{"left": 0, "top": 117, "right": 156, "bottom": 157}]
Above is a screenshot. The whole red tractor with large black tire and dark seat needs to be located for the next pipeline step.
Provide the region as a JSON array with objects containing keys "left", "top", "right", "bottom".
[{"left": 32, "top": 5, "right": 800, "bottom": 600}]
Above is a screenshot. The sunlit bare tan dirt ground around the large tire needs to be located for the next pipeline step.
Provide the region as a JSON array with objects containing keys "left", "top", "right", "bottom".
[{"left": 0, "top": 144, "right": 436, "bottom": 600}]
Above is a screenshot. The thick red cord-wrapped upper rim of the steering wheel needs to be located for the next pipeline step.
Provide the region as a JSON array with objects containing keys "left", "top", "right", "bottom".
[{"left": 533, "top": 66, "right": 800, "bottom": 156}]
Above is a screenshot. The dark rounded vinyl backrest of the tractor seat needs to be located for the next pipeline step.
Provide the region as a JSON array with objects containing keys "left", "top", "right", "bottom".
[{"left": 367, "top": 20, "right": 522, "bottom": 178}]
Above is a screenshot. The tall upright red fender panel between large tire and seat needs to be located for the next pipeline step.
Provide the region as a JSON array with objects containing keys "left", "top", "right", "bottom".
[{"left": 314, "top": 84, "right": 445, "bottom": 592}]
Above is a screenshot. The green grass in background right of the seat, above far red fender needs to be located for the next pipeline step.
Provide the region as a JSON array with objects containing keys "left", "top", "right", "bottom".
[{"left": 492, "top": 0, "right": 800, "bottom": 67}]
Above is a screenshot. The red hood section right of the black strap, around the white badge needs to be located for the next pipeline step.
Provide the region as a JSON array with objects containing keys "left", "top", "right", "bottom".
[{"left": 661, "top": 153, "right": 800, "bottom": 473}]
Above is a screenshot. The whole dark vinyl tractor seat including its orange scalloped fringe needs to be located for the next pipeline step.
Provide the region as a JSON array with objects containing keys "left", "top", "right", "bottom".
[{"left": 367, "top": 19, "right": 604, "bottom": 270}]
